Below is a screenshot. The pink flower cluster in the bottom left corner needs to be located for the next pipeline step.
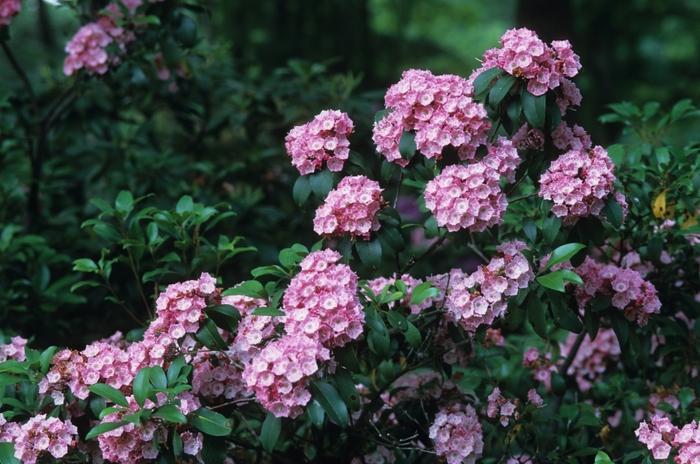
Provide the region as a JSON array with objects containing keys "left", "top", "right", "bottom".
[{"left": 7, "top": 414, "right": 78, "bottom": 464}]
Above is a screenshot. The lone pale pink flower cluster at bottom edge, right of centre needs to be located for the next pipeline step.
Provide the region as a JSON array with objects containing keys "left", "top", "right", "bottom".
[{"left": 428, "top": 404, "right": 484, "bottom": 464}]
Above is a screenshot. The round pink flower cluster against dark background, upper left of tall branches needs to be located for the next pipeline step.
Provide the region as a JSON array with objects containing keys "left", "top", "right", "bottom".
[{"left": 284, "top": 110, "right": 353, "bottom": 175}]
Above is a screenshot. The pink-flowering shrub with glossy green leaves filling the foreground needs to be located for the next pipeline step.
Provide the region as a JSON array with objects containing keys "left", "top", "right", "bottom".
[{"left": 0, "top": 17, "right": 700, "bottom": 464}]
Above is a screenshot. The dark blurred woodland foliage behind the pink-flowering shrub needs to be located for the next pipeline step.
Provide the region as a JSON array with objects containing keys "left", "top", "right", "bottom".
[{"left": 0, "top": 0, "right": 700, "bottom": 346}]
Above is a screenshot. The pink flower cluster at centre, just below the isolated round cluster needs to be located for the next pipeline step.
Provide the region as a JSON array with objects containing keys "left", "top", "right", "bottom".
[{"left": 314, "top": 176, "right": 382, "bottom": 240}]
